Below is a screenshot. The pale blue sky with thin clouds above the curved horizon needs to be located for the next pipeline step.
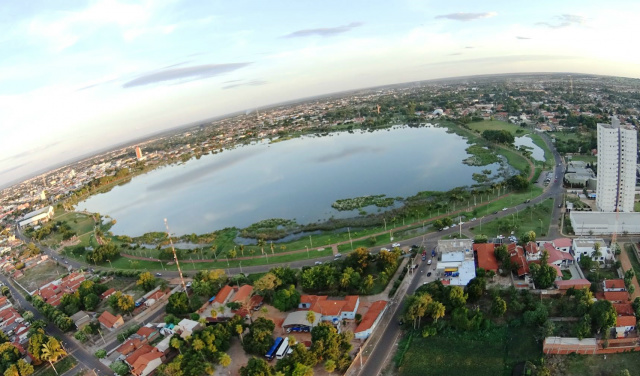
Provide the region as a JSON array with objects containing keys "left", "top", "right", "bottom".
[{"left": 0, "top": 0, "right": 640, "bottom": 186}]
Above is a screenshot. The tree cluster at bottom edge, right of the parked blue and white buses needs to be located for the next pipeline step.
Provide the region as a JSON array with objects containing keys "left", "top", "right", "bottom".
[{"left": 240, "top": 323, "right": 353, "bottom": 376}]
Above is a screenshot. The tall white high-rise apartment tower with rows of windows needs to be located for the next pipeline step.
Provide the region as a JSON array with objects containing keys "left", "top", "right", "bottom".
[{"left": 596, "top": 116, "right": 638, "bottom": 212}]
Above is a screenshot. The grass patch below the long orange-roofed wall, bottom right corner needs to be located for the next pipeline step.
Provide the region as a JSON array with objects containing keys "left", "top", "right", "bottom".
[{"left": 546, "top": 352, "right": 640, "bottom": 376}]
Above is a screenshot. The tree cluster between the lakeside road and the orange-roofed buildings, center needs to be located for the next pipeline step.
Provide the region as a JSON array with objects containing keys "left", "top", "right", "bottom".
[{"left": 300, "top": 248, "right": 400, "bottom": 293}]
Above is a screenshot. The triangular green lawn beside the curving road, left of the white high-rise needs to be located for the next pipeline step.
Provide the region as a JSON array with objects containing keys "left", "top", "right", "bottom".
[{"left": 470, "top": 199, "right": 553, "bottom": 237}]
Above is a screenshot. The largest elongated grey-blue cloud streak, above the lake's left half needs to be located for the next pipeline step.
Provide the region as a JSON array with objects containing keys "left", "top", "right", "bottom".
[{"left": 122, "top": 63, "right": 251, "bottom": 89}]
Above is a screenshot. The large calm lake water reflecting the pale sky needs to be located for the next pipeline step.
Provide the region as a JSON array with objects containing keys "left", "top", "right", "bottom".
[{"left": 77, "top": 126, "right": 499, "bottom": 236}]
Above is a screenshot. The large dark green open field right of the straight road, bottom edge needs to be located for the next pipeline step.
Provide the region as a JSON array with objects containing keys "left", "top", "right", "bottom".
[{"left": 396, "top": 327, "right": 542, "bottom": 376}]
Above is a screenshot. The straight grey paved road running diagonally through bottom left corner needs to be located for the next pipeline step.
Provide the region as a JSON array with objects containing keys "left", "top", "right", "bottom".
[{"left": 0, "top": 275, "right": 113, "bottom": 375}]
